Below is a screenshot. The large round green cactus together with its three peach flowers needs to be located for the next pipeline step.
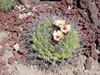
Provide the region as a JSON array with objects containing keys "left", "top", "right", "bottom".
[{"left": 27, "top": 17, "right": 79, "bottom": 63}]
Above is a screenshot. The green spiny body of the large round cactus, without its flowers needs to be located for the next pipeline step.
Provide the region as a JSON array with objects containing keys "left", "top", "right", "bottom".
[{"left": 32, "top": 19, "right": 79, "bottom": 63}]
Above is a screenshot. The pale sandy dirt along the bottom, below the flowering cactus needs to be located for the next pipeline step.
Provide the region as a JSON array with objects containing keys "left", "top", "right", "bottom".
[{"left": 2, "top": 47, "right": 100, "bottom": 75}]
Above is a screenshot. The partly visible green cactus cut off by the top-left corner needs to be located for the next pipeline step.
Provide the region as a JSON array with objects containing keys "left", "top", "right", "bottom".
[{"left": 0, "top": 0, "right": 15, "bottom": 12}]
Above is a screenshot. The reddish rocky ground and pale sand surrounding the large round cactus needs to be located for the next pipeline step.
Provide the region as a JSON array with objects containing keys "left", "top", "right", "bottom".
[{"left": 0, "top": 0, "right": 100, "bottom": 75}]
